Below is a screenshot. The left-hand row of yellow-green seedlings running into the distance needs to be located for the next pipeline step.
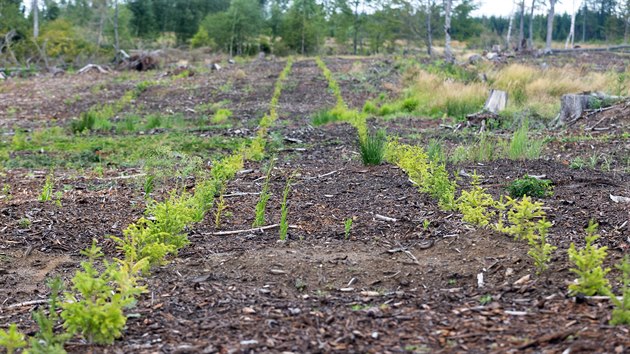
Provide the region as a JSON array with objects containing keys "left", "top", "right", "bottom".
[{"left": 0, "top": 59, "right": 292, "bottom": 353}]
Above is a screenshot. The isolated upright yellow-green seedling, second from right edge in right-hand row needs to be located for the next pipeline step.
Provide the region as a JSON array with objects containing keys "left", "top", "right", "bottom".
[{"left": 569, "top": 220, "right": 610, "bottom": 296}]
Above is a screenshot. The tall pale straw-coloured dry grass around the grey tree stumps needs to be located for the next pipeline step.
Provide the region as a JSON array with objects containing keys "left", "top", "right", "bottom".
[{"left": 382, "top": 60, "right": 630, "bottom": 119}]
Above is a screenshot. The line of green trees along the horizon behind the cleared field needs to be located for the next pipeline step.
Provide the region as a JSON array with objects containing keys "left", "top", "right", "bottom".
[{"left": 0, "top": 0, "right": 630, "bottom": 62}]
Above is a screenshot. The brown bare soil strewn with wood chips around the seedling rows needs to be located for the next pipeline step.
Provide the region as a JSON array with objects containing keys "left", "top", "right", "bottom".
[{"left": 0, "top": 55, "right": 630, "bottom": 353}]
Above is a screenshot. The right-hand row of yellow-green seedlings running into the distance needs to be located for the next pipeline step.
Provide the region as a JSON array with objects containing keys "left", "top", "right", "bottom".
[{"left": 316, "top": 58, "right": 630, "bottom": 324}]
